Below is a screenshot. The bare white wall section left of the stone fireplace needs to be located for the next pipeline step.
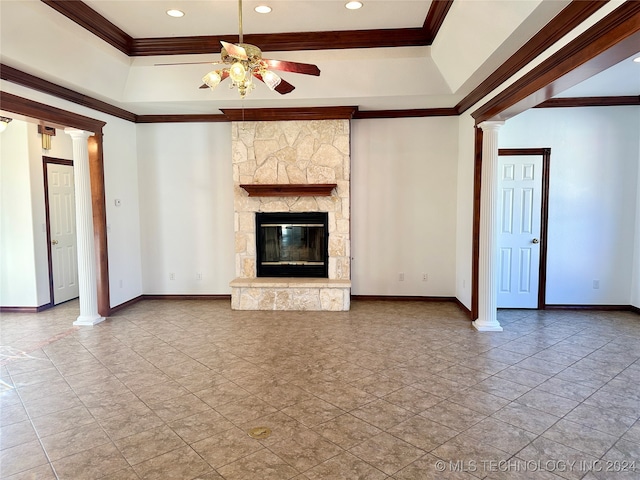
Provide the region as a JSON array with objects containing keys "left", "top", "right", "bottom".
[{"left": 137, "top": 123, "right": 235, "bottom": 294}]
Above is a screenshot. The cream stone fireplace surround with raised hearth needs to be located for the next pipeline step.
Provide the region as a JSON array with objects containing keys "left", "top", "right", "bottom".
[{"left": 231, "top": 120, "right": 351, "bottom": 311}]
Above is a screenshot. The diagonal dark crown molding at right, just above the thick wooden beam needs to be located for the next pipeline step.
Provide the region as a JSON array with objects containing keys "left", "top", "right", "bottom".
[{"left": 455, "top": 0, "right": 607, "bottom": 115}]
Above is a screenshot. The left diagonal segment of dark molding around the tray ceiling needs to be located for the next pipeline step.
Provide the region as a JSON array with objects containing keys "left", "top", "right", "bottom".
[{"left": 42, "top": 0, "right": 133, "bottom": 55}]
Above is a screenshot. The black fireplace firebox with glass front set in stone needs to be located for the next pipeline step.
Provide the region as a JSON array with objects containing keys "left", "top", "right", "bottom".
[{"left": 256, "top": 212, "right": 329, "bottom": 278}]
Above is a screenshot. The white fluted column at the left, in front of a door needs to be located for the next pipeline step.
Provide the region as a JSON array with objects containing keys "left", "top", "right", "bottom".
[{"left": 64, "top": 128, "right": 104, "bottom": 325}]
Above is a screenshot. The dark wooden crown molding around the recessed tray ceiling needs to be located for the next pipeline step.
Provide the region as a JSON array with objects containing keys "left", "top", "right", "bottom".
[{"left": 41, "top": 0, "right": 453, "bottom": 57}]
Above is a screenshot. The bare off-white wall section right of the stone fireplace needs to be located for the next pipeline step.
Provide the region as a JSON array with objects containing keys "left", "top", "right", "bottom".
[{"left": 351, "top": 117, "right": 458, "bottom": 296}]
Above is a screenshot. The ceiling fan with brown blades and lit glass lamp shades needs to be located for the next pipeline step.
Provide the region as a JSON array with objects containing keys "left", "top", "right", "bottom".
[{"left": 156, "top": 0, "right": 320, "bottom": 98}]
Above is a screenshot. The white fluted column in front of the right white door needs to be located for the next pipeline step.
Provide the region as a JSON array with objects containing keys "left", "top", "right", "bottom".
[{"left": 473, "top": 122, "right": 504, "bottom": 332}]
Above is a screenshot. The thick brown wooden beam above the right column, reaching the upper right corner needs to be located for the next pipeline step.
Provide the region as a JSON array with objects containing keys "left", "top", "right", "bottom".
[{"left": 471, "top": 2, "right": 640, "bottom": 124}]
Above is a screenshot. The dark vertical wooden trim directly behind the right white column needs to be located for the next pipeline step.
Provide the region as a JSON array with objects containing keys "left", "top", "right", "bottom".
[{"left": 471, "top": 126, "right": 482, "bottom": 320}]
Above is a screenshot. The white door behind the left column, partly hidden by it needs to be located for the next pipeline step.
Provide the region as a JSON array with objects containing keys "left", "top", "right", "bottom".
[{"left": 47, "top": 163, "right": 79, "bottom": 305}]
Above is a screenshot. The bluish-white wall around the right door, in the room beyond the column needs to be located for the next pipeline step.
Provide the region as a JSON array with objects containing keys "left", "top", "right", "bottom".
[{"left": 500, "top": 107, "right": 640, "bottom": 305}]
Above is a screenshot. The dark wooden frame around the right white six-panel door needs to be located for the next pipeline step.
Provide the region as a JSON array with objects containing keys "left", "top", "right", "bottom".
[{"left": 498, "top": 148, "right": 551, "bottom": 310}]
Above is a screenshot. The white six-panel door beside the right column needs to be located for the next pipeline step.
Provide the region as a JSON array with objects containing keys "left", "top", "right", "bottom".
[{"left": 498, "top": 155, "right": 543, "bottom": 308}]
